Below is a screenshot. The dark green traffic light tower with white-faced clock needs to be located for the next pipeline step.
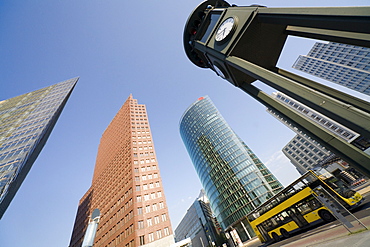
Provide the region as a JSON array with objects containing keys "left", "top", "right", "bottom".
[{"left": 183, "top": 0, "right": 370, "bottom": 177}]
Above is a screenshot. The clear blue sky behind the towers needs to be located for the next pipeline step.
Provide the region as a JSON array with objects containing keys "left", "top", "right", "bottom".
[{"left": 0, "top": 0, "right": 369, "bottom": 247}]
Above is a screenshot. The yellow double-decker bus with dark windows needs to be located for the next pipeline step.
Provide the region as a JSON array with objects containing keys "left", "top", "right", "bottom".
[{"left": 247, "top": 171, "right": 363, "bottom": 243}]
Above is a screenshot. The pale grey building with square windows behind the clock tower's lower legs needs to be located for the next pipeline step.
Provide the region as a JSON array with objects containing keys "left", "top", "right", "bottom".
[{"left": 267, "top": 92, "right": 370, "bottom": 185}]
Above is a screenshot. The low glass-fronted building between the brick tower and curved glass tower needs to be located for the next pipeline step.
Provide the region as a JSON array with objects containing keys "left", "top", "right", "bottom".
[{"left": 175, "top": 190, "right": 226, "bottom": 247}]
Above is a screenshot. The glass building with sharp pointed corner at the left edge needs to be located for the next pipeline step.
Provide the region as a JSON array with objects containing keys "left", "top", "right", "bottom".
[{"left": 0, "top": 78, "right": 78, "bottom": 218}]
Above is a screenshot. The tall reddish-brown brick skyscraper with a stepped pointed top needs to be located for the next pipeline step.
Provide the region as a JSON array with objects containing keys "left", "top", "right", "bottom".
[{"left": 69, "top": 95, "right": 174, "bottom": 247}]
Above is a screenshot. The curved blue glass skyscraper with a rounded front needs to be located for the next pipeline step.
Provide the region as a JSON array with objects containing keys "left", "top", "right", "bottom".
[{"left": 180, "top": 96, "right": 282, "bottom": 241}]
